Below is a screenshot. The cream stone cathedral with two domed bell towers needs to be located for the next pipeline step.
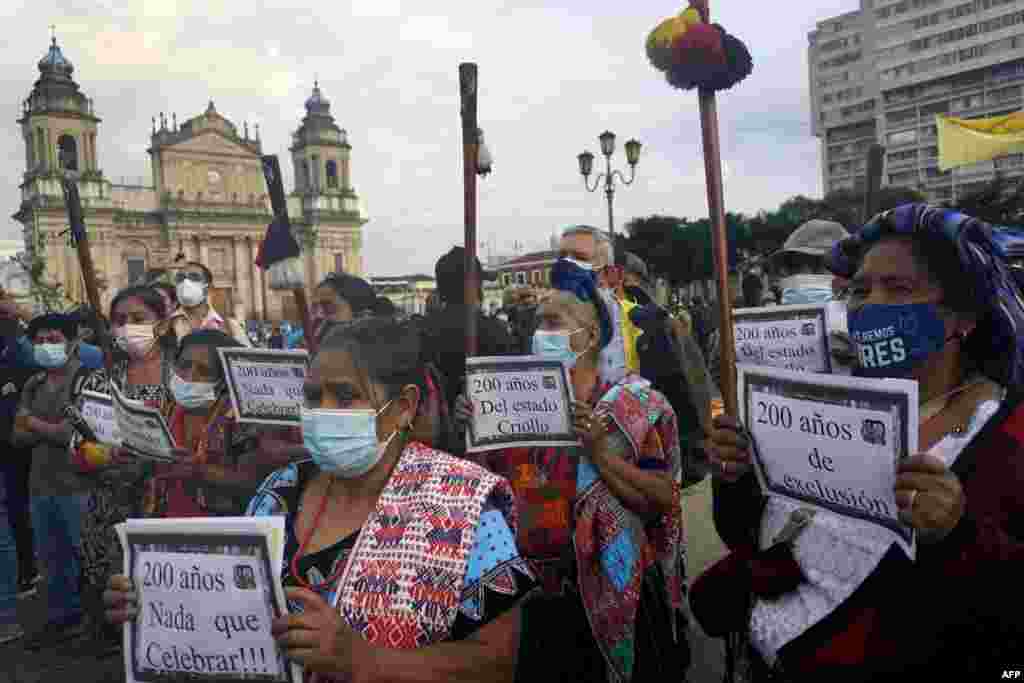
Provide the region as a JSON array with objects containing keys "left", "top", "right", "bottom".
[{"left": 14, "top": 38, "right": 367, "bottom": 322}]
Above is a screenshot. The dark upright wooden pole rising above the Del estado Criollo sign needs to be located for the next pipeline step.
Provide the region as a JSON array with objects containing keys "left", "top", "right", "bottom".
[{"left": 459, "top": 63, "right": 480, "bottom": 356}]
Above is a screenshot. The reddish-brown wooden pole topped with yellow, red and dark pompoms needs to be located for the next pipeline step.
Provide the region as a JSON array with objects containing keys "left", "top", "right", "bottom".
[{"left": 697, "top": 0, "right": 738, "bottom": 417}]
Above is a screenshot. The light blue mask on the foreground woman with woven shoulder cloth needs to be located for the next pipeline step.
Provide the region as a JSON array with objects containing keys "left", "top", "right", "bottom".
[{"left": 302, "top": 401, "right": 398, "bottom": 479}]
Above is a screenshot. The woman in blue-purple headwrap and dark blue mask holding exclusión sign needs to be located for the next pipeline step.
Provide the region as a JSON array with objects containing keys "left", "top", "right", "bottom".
[{"left": 691, "top": 205, "right": 1024, "bottom": 682}]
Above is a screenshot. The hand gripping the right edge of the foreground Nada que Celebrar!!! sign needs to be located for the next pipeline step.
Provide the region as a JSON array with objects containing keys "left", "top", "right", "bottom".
[{"left": 271, "top": 588, "right": 370, "bottom": 679}]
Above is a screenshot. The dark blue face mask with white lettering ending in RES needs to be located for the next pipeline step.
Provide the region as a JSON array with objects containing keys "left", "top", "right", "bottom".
[{"left": 847, "top": 303, "right": 951, "bottom": 379}]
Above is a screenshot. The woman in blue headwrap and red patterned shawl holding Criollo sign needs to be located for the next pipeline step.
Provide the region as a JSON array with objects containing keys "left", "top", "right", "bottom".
[{"left": 459, "top": 260, "right": 686, "bottom": 682}]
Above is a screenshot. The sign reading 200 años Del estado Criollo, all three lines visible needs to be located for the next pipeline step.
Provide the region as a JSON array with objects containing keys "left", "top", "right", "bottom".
[{"left": 466, "top": 355, "right": 580, "bottom": 453}]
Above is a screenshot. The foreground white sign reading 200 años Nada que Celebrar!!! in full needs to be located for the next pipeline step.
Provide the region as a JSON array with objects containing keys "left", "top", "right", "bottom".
[{"left": 119, "top": 518, "right": 301, "bottom": 683}]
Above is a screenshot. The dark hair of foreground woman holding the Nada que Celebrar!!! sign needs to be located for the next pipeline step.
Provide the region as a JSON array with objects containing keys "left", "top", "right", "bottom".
[{"left": 319, "top": 316, "right": 427, "bottom": 399}]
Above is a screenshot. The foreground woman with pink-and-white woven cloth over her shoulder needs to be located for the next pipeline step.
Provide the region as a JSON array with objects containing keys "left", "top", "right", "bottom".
[{"left": 106, "top": 318, "right": 535, "bottom": 682}]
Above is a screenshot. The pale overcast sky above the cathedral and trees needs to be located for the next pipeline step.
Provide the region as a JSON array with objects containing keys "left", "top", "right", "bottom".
[{"left": 0, "top": 0, "right": 858, "bottom": 275}]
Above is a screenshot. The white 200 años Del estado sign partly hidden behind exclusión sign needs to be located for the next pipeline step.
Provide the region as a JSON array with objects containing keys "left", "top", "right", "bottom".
[{"left": 732, "top": 304, "right": 838, "bottom": 373}]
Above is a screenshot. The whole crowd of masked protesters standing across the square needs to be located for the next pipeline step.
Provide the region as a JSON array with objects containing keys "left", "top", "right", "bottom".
[{"left": 0, "top": 205, "right": 1024, "bottom": 682}]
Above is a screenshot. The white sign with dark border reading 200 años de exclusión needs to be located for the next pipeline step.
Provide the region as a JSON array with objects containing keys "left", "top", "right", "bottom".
[{"left": 737, "top": 366, "right": 919, "bottom": 559}]
